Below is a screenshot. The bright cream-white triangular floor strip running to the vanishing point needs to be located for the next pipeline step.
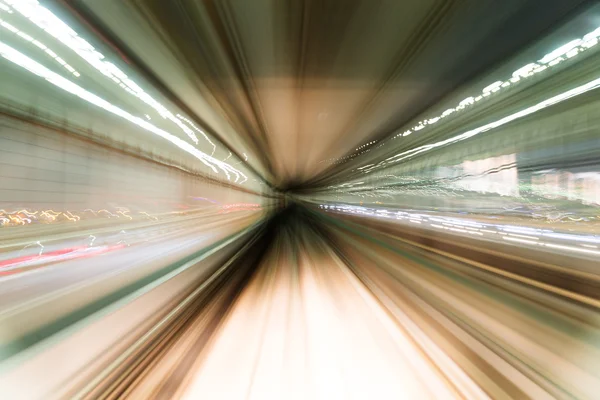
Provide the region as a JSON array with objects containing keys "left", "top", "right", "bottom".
[{"left": 184, "top": 214, "right": 486, "bottom": 399}]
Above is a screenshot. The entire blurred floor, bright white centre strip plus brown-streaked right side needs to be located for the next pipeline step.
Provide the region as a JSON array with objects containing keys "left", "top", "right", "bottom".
[{"left": 101, "top": 207, "right": 600, "bottom": 399}]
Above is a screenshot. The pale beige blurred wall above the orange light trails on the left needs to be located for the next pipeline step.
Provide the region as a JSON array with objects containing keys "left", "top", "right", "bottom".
[{"left": 0, "top": 118, "right": 263, "bottom": 213}]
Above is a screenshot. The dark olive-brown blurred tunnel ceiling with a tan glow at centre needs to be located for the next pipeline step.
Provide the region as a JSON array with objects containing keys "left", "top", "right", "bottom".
[{"left": 64, "top": 0, "right": 589, "bottom": 188}]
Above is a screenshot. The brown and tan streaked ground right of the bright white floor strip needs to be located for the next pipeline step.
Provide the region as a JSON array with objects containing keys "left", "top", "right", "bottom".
[{"left": 316, "top": 208, "right": 600, "bottom": 399}]
